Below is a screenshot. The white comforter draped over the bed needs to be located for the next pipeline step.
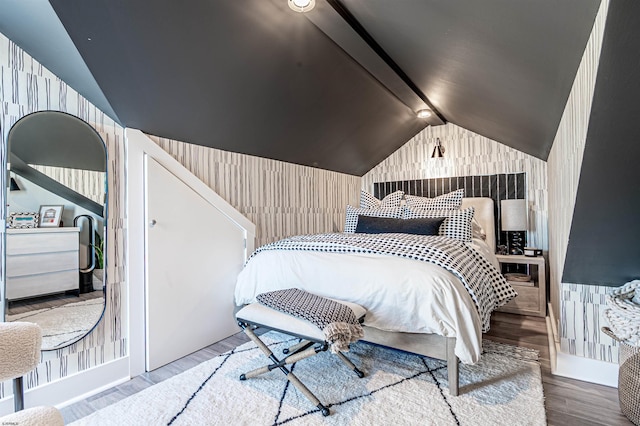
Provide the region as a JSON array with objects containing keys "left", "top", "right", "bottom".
[{"left": 235, "top": 240, "right": 497, "bottom": 364}]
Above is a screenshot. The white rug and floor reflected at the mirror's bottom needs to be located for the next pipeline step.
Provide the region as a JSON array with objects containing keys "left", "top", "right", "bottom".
[{"left": 7, "top": 297, "right": 104, "bottom": 349}]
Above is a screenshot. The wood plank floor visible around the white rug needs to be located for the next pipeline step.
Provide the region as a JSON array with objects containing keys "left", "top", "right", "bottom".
[{"left": 61, "top": 312, "right": 632, "bottom": 426}]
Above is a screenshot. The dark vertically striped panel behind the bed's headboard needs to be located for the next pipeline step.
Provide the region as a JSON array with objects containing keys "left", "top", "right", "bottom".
[{"left": 373, "top": 173, "right": 531, "bottom": 245}]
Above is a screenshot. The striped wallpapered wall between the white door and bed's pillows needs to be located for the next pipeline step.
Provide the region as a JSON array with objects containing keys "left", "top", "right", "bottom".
[{"left": 149, "top": 136, "right": 360, "bottom": 247}]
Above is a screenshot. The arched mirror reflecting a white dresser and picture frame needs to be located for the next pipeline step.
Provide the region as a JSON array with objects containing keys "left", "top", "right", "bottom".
[{"left": 4, "top": 111, "right": 107, "bottom": 350}]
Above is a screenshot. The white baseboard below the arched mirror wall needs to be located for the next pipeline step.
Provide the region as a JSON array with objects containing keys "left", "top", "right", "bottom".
[{"left": 0, "top": 357, "right": 130, "bottom": 415}]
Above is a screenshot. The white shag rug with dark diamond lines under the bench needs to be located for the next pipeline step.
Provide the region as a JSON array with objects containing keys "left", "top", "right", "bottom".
[{"left": 73, "top": 332, "right": 546, "bottom": 426}]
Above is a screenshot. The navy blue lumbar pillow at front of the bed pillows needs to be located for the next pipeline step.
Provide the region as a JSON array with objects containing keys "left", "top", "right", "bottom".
[{"left": 356, "top": 215, "right": 446, "bottom": 235}]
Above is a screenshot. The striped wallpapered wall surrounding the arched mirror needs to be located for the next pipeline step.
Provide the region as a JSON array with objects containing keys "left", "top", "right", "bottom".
[{"left": 0, "top": 34, "right": 127, "bottom": 398}]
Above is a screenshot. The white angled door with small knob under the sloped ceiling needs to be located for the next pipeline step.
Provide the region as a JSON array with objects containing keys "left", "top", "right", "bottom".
[{"left": 145, "top": 156, "right": 245, "bottom": 371}]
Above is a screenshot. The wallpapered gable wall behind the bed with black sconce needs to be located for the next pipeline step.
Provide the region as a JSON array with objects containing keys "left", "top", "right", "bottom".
[{"left": 362, "top": 123, "right": 549, "bottom": 250}]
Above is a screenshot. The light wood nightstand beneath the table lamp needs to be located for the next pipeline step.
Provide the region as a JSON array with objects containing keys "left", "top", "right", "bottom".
[{"left": 496, "top": 254, "right": 547, "bottom": 317}]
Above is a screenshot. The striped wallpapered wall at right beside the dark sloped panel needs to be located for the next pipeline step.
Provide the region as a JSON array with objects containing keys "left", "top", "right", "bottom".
[{"left": 547, "top": 0, "right": 618, "bottom": 362}]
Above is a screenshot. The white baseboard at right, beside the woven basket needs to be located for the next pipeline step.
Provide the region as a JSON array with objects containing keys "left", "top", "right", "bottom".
[{"left": 547, "top": 307, "right": 619, "bottom": 388}]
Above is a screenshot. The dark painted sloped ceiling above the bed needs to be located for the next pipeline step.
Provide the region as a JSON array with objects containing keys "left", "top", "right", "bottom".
[{"left": 0, "top": 0, "right": 599, "bottom": 175}]
